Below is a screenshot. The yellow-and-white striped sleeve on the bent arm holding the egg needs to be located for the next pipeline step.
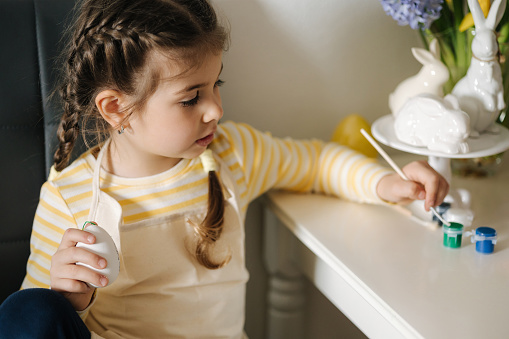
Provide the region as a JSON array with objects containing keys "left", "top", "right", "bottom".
[{"left": 21, "top": 182, "right": 76, "bottom": 289}]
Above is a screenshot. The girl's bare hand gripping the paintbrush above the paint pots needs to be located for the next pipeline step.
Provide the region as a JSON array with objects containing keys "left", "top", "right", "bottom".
[{"left": 377, "top": 160, "right": 449, "bottom": 211}]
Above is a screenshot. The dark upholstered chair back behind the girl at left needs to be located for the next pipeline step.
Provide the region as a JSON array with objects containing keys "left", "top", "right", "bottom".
[{"left": 0, "top": 0, "right": 74, "bottom": 302}]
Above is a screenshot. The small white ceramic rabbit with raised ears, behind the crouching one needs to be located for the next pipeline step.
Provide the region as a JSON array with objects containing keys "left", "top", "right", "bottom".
[{"left": 389, "top": 39, "right": 449, "bottom": 116}]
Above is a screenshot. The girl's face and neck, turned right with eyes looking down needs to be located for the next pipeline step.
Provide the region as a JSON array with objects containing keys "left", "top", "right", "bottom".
[{"left": 111, "top": 53, "right": 223, "bottom": 177}]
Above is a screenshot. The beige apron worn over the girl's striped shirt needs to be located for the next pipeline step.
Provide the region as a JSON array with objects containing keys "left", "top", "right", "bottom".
[{"left": 86, "top": 139, "right": 248, "bottom": 338}]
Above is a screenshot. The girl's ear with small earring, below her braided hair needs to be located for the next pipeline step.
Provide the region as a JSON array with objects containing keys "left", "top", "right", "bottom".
[{"left": 95, "top": 89, "right": 127, "bottom": 129}]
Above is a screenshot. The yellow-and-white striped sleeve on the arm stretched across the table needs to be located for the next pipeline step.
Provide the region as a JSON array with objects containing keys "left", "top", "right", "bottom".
[{"left": 222, "top": 122, "right": 392, "bottom": 203}]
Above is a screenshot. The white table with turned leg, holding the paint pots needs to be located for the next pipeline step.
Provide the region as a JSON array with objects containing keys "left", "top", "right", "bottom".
[{"left": 265, "top": 156, "right": 509, "bottom": 339}]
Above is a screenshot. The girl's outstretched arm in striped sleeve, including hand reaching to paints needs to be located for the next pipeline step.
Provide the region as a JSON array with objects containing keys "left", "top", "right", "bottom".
[{"left": 215, "top": 122, "right": 449, "bottom": 210}]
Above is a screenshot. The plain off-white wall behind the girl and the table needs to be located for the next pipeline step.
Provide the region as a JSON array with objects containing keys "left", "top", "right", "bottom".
[{"left": 215, "top": 0, "right": 421, "bottom": 339}]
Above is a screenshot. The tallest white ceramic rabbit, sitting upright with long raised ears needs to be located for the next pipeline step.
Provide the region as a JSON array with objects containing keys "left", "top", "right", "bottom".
[{"left": 452, "top": 0, "right": 507, "bottom": 136}]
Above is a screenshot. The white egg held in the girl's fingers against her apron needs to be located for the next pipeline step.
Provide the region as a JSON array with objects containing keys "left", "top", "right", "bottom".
[{"left": 76, "top": 224, "right": 120, "bottom": 288}]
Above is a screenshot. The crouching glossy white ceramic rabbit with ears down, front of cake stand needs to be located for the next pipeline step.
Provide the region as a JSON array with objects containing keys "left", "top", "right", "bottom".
[{"left": 394, "top": 93, "right": 470, "bottom": 154}]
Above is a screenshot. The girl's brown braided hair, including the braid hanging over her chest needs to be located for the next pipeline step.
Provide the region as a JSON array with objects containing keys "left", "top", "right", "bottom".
[{"left": 54, "top": 0, "right": 229, "bottom": 268}]
